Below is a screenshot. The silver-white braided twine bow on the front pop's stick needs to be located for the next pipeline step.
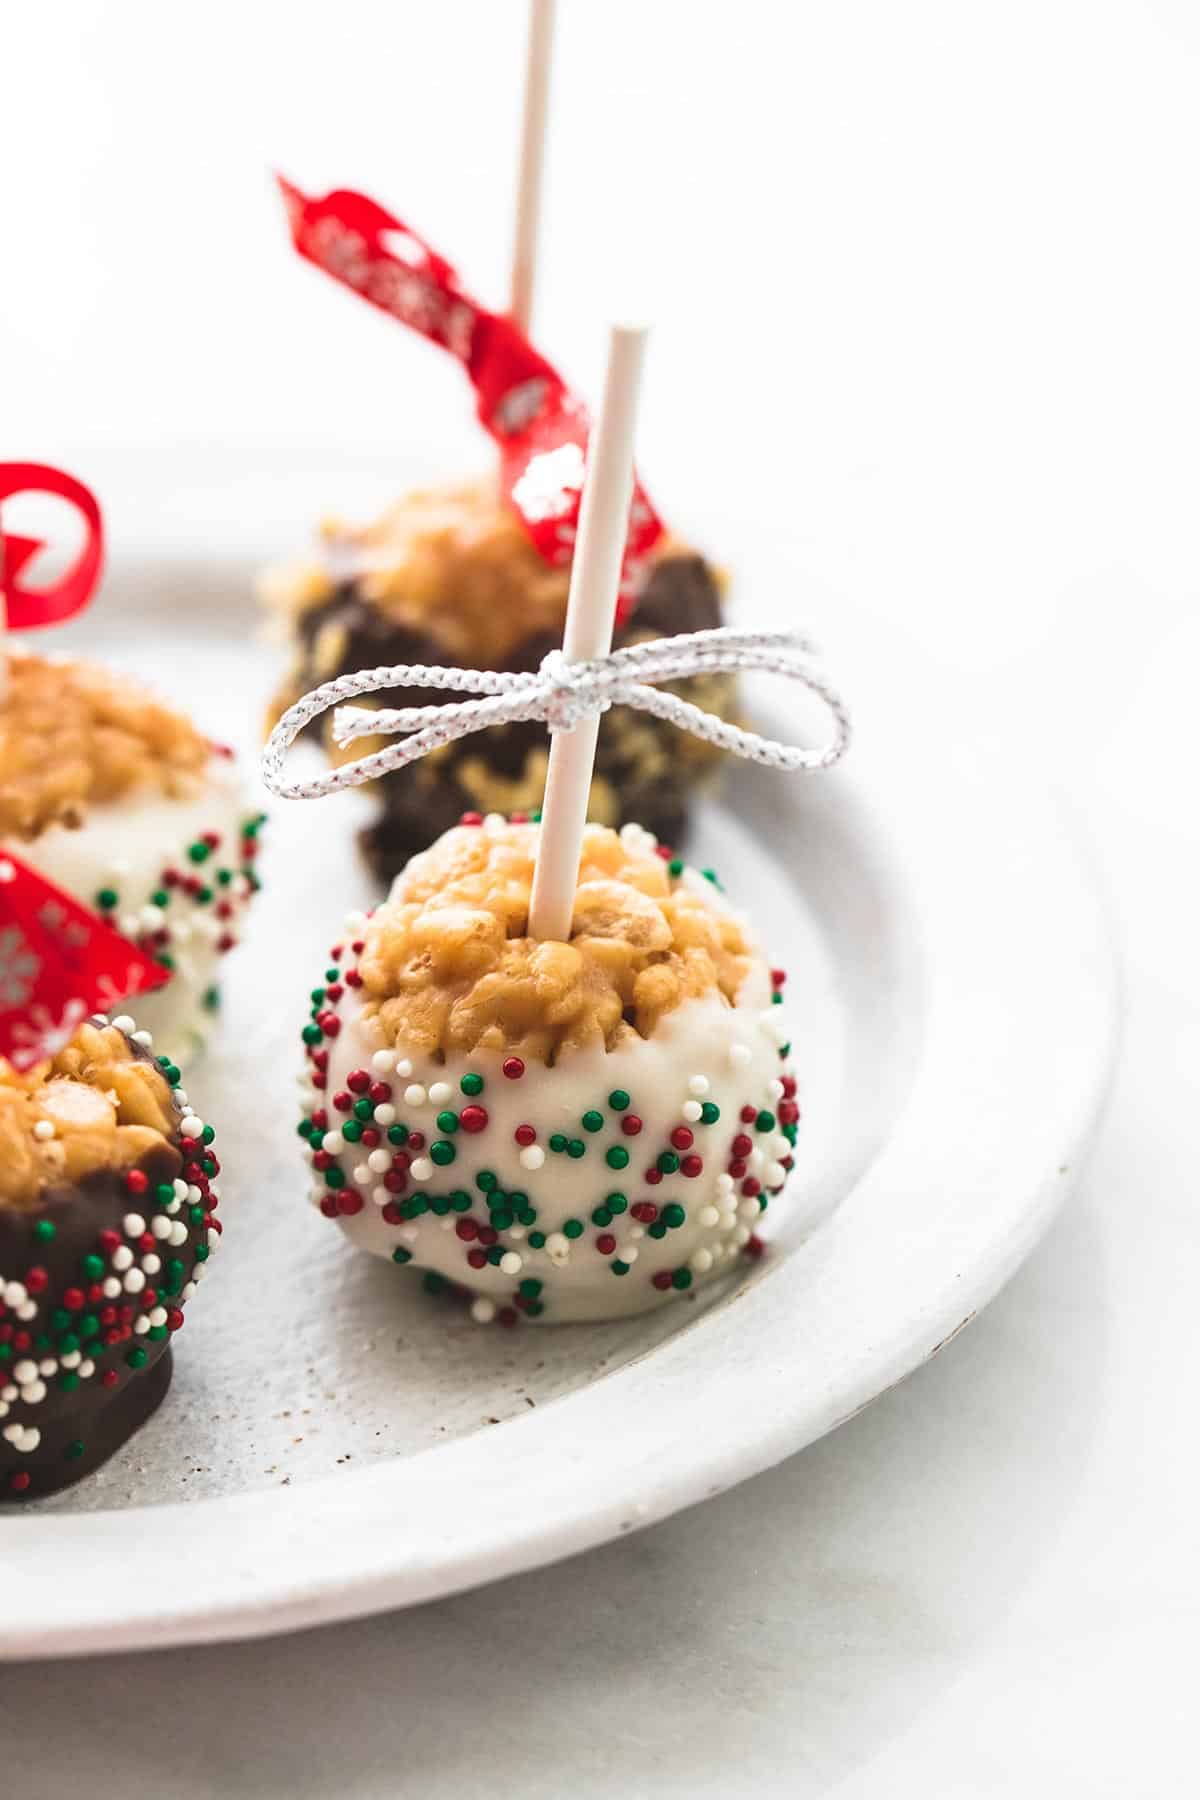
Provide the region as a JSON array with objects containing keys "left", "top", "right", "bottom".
[{"left": 263, "top": 626, "right": 851, "bottom": 799}]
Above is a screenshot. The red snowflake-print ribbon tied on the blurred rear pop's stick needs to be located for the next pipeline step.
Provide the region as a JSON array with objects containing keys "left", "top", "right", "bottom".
[{"left": 279, "top": 176, "right": 664, "bottom": 621}]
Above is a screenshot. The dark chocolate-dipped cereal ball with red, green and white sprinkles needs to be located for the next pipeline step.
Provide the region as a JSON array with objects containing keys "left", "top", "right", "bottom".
[{"left": 0, "top": 1019, "right": 221, "bottom": 1499}]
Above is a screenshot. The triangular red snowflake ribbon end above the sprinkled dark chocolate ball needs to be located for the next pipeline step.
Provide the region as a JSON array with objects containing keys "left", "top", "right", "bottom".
[{"left": 0, "top": 850, "right": 167, "bottom": 1069}]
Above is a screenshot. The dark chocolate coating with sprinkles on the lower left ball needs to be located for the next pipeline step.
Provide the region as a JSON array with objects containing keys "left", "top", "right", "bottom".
[{"left": 0, "top": 1044, "right": 207, "bottom": 1499}]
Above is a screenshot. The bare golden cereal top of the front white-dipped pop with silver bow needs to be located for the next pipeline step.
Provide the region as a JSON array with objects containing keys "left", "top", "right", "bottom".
[{"left": 358, "top": 824, "right": 752, "bottom": 1064}]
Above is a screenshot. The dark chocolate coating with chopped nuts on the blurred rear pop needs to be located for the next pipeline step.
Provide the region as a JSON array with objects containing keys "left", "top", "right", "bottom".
[{"left": 287, "top": 551, "right": 732, "bottom": 882}]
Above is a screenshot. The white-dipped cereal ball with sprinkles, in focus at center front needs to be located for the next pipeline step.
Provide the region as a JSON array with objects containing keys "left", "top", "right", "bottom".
[{"left": 300, "top": 817, "right": 799, "bottom": 1323}]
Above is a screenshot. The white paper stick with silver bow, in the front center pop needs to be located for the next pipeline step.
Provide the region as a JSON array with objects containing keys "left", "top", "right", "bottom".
[{"left": 529, "top": 326, "right": 646, "bottom": 943}]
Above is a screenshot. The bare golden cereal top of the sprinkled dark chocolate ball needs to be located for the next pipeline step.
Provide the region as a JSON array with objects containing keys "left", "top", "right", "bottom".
[{"left": 0, "top": 1024, "right": 175, "bottom": 1211}]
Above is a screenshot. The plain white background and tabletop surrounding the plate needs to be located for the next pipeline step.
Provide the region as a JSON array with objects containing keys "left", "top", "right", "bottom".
[{"left": 0, "top": 0, "right": 1200, "bottom": 1800}]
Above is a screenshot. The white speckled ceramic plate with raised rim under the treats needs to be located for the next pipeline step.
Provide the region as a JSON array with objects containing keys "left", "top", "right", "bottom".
[{"left": 0, "top": 529, "right": 1117, "bottom": 1656}]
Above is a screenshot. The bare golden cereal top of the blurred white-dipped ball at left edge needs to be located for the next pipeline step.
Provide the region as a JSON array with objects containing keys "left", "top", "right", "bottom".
[{"left": 0, "top": 657, "right": 212, "bottom": 841}]
